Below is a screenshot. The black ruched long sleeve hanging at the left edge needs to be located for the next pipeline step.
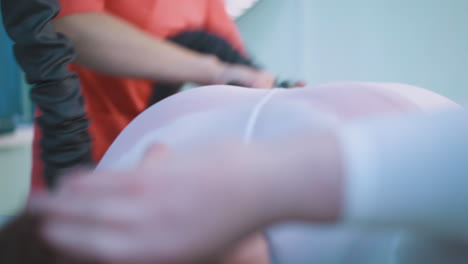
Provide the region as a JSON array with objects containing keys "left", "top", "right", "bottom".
[{"left": 1, "top": 0, "right": 92, "bottom": 187}]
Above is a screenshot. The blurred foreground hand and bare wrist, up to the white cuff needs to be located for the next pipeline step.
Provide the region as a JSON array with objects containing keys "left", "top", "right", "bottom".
[{"left": 32, "top": 132, "right": 343, "bottom": 264}]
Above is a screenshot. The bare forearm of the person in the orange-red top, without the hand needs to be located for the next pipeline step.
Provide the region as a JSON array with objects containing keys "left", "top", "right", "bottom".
[{"left": 55, "top": 13, "right": 225, "bottom": 84}]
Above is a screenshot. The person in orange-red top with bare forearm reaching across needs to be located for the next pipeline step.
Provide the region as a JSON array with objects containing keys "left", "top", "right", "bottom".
[{"left": 33, "top": 0, "right": 273, "bottom": 188}]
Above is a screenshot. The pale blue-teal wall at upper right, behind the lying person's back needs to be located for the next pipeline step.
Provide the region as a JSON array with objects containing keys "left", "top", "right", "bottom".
[{"left": 238, "top": 0, "right": 468, "bottom": 102}]
